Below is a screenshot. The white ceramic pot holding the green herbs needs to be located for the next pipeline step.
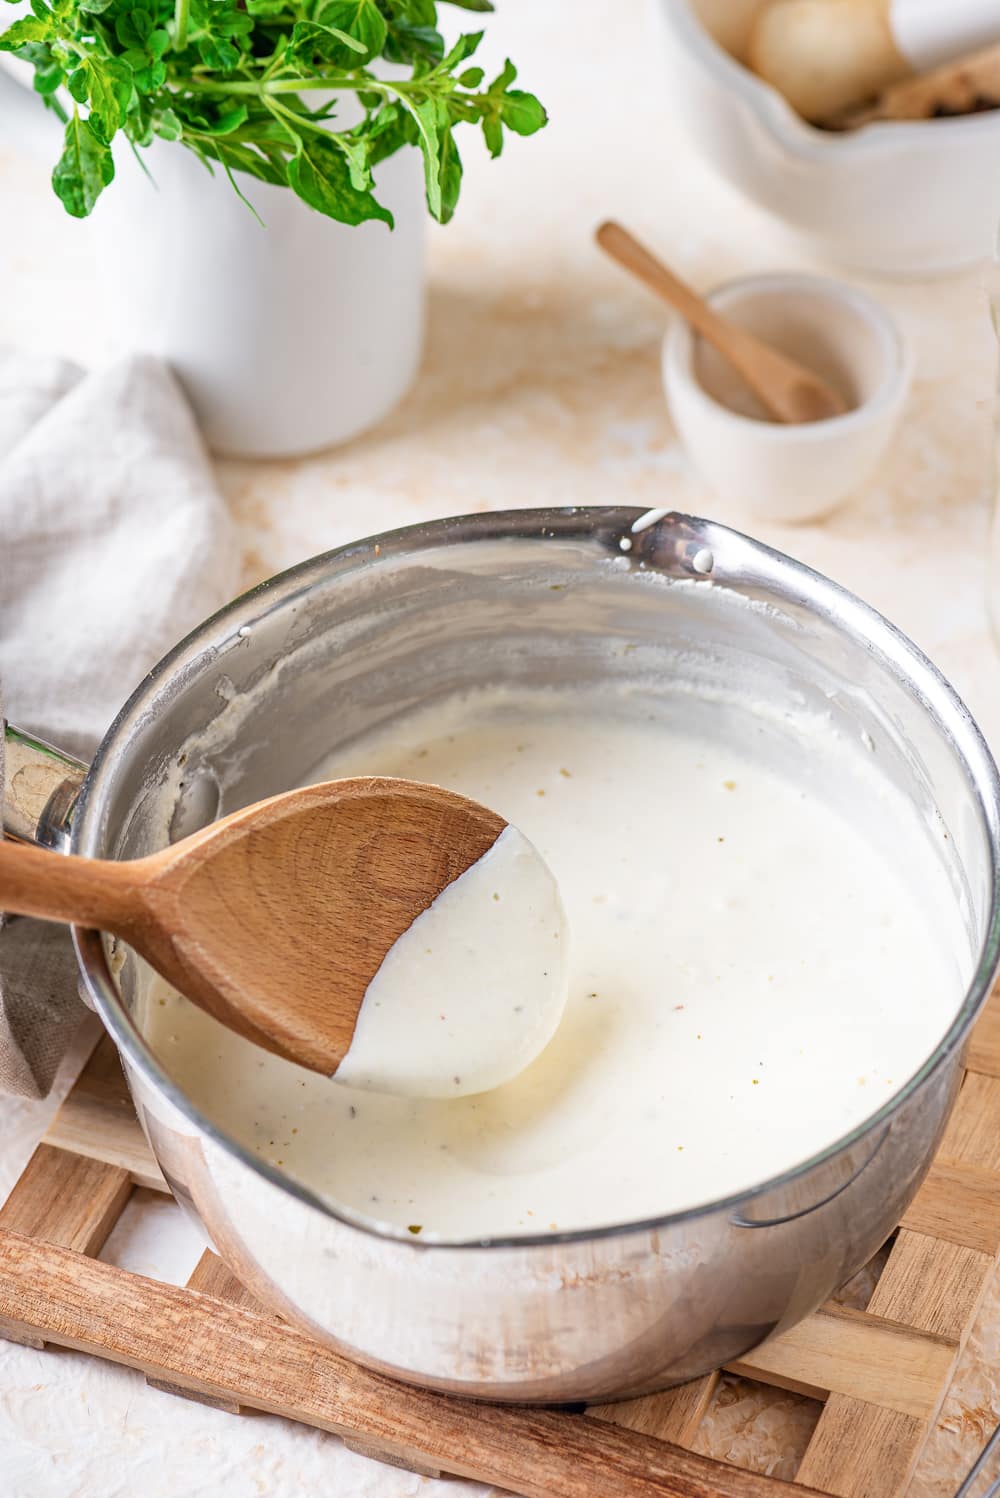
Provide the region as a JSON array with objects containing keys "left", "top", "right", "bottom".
[{"left": 91, "top": 141, "right": 425, "bottom": 457}]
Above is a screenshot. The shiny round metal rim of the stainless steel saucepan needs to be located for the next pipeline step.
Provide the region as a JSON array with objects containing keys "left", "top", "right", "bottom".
[{"left": 70, "top": 506, "right": 1000, "bottom": 1254}]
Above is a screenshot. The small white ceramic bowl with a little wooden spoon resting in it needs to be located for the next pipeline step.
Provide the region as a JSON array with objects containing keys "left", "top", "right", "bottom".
[{"left": 663, "top": 273, "right": 910, "bottom": 521}]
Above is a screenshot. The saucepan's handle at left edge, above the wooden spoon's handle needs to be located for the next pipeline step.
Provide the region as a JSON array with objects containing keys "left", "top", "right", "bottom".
[{"left": 3, "top": 724, "right": 87, "bottom": 852}]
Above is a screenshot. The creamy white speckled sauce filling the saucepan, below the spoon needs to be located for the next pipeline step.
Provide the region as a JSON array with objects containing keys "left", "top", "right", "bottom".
[{"left": 147, "top": 692, "right": 963, "bottom": 1239}]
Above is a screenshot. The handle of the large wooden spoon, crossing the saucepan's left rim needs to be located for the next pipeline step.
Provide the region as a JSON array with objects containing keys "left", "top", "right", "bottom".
[{"left": 0, "top": 839, "right": 142, "bottom": 935}]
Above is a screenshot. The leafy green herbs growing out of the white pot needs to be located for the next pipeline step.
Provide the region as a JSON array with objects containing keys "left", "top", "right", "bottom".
[{"left": 0, "top": 0, "right": 545, "bottom": 225}]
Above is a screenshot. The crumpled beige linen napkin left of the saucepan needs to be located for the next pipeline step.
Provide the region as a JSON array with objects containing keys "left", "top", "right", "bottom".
[{"left": 0, "top": 349, "right": 237, "bottom": 1097}]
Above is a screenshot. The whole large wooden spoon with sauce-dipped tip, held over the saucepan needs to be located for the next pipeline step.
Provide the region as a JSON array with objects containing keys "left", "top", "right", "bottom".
[{"left": 0, "top": 777, "right": 567, "bottom": 1097}]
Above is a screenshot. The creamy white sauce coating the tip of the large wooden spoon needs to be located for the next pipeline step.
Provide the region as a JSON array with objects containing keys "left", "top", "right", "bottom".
[{"left": 334, "top": 827, "right": 569, "bottom": 1098}]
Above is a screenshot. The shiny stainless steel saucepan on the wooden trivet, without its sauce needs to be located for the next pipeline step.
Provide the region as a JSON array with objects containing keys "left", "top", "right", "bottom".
[{"left": 7, "top": 509, "right": 1000, "bottom": 1401}]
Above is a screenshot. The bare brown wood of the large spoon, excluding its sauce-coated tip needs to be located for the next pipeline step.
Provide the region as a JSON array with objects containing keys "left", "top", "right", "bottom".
[{"left": 0, "top": 777, "right": 507, "bottom": 1076}]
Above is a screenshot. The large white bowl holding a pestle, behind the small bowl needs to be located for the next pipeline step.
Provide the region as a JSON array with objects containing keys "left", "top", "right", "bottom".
[{"left": 657, "top": 0, "right": 1000, "bottom": 274}]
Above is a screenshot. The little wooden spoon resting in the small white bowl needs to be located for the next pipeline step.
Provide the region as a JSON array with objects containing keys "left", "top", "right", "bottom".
[{"left": 596, "top": 223, "right": 847, "bottom": 425}]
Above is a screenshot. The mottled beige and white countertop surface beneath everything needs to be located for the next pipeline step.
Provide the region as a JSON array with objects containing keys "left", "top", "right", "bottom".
[{"left": 0, "top": 0, "right": 1000, "bottom": 1498}]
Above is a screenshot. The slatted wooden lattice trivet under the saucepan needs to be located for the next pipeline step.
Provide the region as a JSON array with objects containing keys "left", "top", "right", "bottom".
[{"left": 0, "top": 993, "right": 1000, "bottom": 1498}]
